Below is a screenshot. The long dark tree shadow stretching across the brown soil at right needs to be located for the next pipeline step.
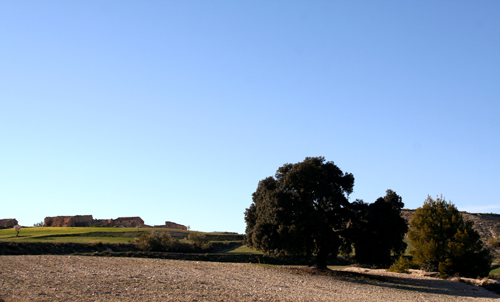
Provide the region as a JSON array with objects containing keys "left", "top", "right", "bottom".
[{"left": 287, "top": 268, "right": 500, "bottom": 298}]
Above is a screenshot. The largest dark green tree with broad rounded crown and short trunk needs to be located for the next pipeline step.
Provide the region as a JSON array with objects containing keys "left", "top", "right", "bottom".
[{"left": 245, "top": 157, "right": 354, "bottom": 268}]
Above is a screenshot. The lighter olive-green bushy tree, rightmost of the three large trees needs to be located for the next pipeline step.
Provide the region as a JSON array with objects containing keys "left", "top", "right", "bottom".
[{"left": 408, "top": 197, "right": 491, "bottom": 278}]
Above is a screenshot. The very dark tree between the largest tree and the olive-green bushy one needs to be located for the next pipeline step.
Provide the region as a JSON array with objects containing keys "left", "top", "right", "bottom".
[{"left": 351, "top": 190, "right": 408, "bottom": 267}]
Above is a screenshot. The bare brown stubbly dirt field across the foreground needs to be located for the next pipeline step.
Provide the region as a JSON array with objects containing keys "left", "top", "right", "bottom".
[{"left": 0, "top": 256, "right": 500, "bottom": 302}]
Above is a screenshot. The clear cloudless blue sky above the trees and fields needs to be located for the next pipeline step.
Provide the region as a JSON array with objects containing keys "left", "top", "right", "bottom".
[{"left": 0, "top": 0, "right": 500, "bottom": 233}]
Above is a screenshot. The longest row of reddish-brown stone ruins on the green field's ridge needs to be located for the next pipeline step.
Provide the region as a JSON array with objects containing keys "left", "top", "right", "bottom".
[{"left": 43, "top": 215, "right": 144, "bottom": 227}]
